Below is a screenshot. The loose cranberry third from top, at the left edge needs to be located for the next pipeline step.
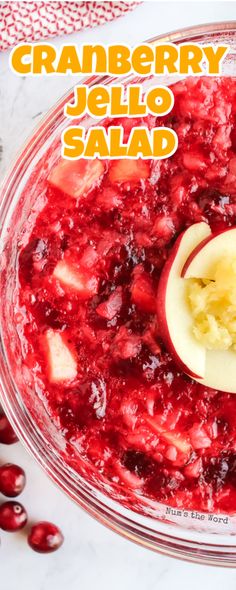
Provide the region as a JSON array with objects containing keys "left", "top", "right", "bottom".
[{"left": 0, "top": 502, "right": 27, "bottom": 533}]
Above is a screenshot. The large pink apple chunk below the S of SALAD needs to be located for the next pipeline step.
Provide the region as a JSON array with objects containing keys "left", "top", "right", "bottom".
[{"left": 48, "top": 159, "right": 104, "bottom": 199}]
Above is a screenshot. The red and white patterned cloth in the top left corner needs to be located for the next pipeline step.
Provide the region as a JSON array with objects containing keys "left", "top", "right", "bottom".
[{"left": 0, "top": 1, "right": 140, "bottom": 51}]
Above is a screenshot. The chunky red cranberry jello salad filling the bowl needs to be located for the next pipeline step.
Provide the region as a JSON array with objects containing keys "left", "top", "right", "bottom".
[{"left": 15, "top": 77, "right": 236, "bottom": 512}]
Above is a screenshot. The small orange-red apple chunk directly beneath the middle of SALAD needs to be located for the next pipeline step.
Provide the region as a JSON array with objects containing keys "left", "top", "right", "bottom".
[{"left": 108, "top": 159, "right": 150, "bottom": 183}]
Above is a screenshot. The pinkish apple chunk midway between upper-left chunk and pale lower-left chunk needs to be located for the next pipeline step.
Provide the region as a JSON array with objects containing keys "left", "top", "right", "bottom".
[{"left": 53, "top": 260, "right": 98, "bottom": 299}]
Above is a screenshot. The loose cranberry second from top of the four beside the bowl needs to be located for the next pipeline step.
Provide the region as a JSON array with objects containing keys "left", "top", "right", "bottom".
[{"left": 0, "top": 463, "right": 26, "bottom": 498}]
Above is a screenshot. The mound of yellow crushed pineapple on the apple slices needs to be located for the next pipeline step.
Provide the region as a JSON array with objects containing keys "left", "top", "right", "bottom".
[{"left": 187, "top": 257, "right": 236, "bottom": 350}]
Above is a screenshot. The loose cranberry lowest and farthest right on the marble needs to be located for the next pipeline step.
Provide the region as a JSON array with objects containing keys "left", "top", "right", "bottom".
[{"left": 28, "top": 522, "right": 64, "bottom": 553}]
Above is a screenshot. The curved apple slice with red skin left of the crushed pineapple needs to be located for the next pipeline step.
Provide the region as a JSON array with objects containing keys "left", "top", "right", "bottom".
[{"left": 157, "top": 222, "right": 211, "bottom": 379}]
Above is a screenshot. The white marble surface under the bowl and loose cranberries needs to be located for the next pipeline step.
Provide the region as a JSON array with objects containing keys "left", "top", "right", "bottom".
[{"left": 0, "top": 0, "right": 236, "bottom": 590}]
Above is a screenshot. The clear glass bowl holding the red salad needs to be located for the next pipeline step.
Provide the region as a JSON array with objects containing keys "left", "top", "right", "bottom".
[{"left": 0, "top": 21, "right": 236, "bottom": 567}]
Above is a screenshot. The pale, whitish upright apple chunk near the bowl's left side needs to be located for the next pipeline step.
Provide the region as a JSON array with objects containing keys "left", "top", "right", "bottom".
[{"left": 43, "top": 330, "right": 77, "bottom": 383}]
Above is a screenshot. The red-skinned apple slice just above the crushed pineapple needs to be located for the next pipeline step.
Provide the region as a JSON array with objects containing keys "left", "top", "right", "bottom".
[{"left": 181, "top": 227, "right": 236, "bottom": 280}]
